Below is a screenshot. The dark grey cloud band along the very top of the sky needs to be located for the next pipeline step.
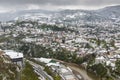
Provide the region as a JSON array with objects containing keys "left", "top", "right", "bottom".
[{"left": 0, "top": 0, "right": 120, "bottom": 6}]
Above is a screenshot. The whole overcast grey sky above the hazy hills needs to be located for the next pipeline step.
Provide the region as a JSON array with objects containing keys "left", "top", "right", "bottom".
[{"left": 0, "top": 0, "right": 120, "bottom": 13}]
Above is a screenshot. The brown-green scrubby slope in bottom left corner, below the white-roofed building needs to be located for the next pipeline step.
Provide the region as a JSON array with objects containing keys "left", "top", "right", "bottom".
[{"left": 0, "top": 51, "right": 18, "bottom": 80}]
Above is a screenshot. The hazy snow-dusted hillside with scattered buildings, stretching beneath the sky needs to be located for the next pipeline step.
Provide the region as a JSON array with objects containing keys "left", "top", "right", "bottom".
[{"left": 0, "top": 5, "right": 120, "bottom": 24}]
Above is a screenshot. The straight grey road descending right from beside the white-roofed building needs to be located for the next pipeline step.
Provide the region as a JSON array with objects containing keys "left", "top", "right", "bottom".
[{"left": 28, "top": 61, "right": 53, "bottom": 80}]
